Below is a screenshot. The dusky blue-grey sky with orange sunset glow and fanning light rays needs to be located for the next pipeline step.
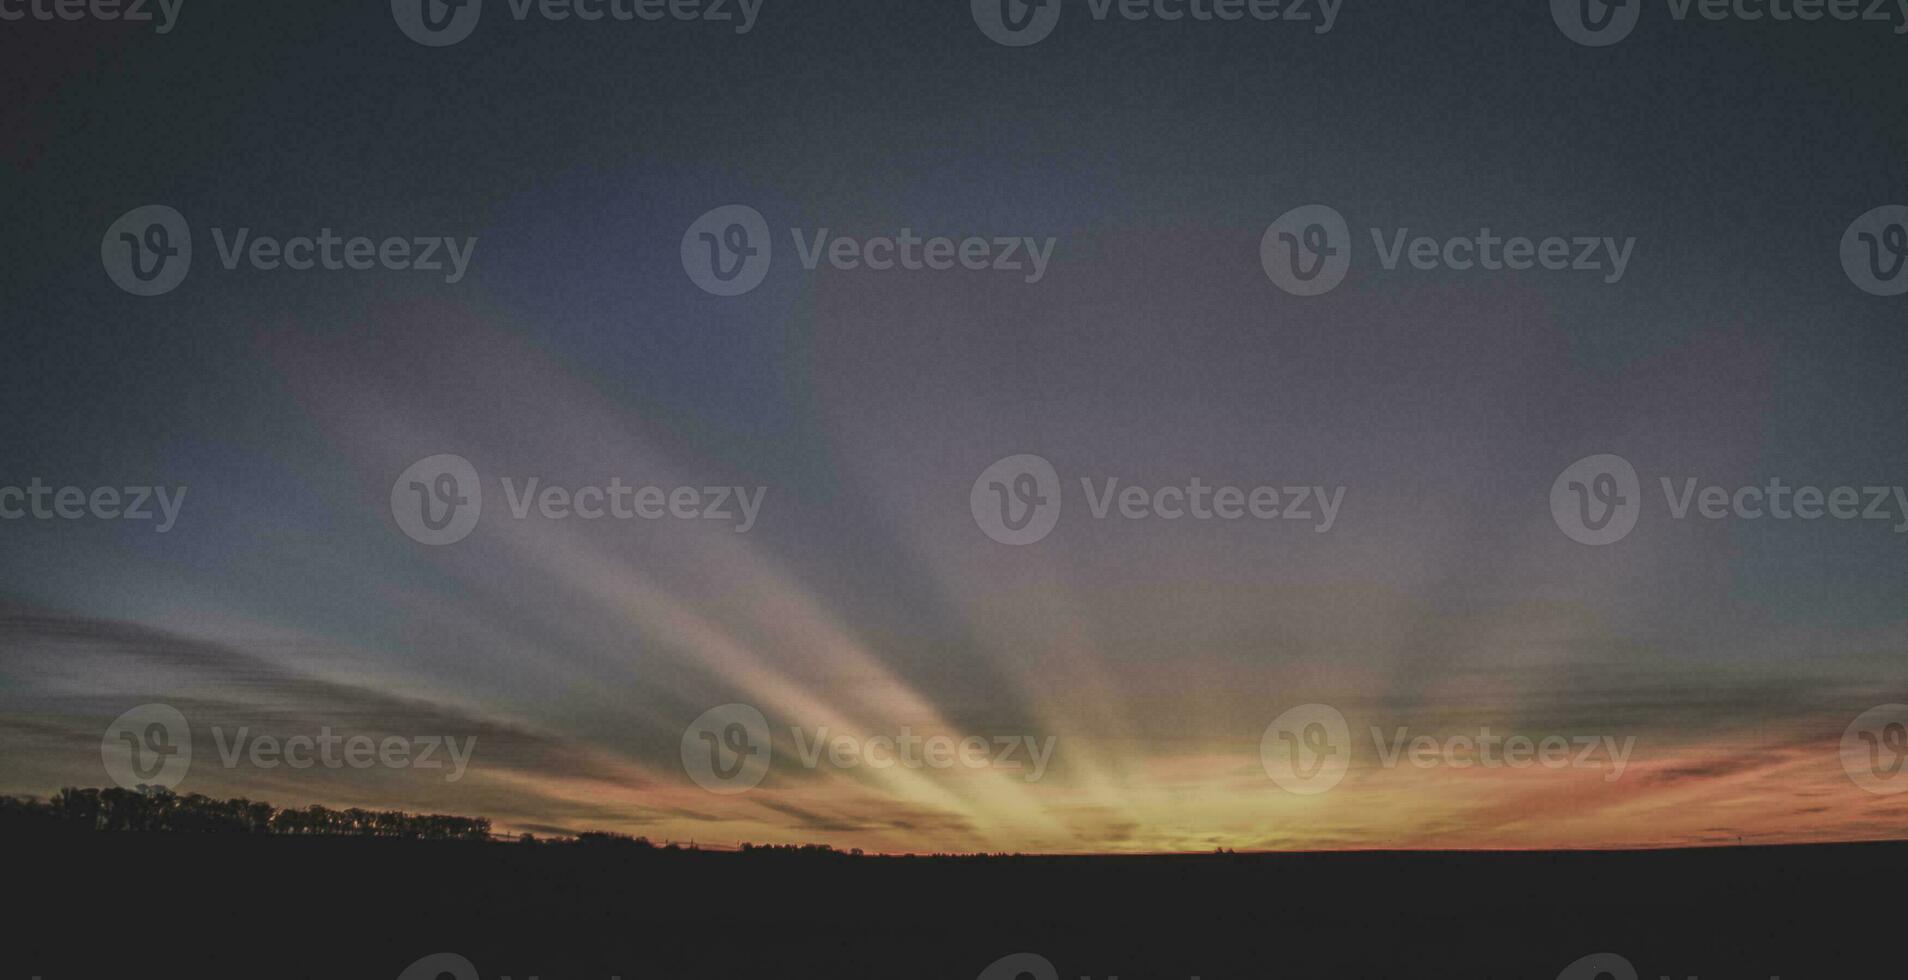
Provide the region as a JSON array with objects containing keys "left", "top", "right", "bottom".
[{"left": 0, "top": 0, "right": 1908, "bottom": 852}]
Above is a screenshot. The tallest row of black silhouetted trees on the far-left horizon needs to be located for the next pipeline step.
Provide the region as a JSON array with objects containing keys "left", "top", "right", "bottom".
[{"left": 0, "top": 787, "right": 490, "bottom": 841}]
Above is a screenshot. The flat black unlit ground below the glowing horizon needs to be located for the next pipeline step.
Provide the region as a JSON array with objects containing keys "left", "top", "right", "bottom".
[{"left": 0, "top": 833, "right": 1908, "bottom": 980}]
